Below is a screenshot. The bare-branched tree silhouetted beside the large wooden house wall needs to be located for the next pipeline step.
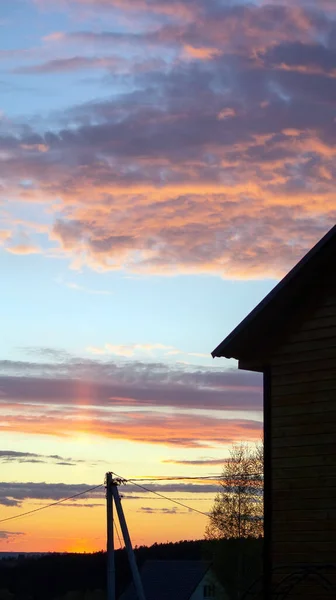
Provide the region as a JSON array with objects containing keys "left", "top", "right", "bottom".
[{"left": 205, "top": 443, "right": 263, "bottom": 539}]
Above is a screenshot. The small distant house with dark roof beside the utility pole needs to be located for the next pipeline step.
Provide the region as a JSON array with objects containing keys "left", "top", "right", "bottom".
[{"left": 119, "top": 560, "right": 229, "bottom": 600}]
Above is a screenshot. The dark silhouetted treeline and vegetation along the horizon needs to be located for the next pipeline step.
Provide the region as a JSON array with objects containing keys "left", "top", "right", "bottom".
[{"left": 0, "top": 539, "right": 262, "bottom": 600}]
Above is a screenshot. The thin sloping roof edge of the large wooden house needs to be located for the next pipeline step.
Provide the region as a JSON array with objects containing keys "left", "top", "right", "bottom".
[{"left": 211, "top": 225, "right": 336, "bottom": 358}]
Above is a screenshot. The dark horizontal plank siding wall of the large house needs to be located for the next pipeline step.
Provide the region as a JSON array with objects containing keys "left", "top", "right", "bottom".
[{"left": 271, "top": 283, "right": 336, "bottom": 600}]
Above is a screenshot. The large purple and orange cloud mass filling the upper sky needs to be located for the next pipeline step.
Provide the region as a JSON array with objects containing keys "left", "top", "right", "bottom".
[{"left": 0, "top": 0, "right": 336, "bottom": 278}]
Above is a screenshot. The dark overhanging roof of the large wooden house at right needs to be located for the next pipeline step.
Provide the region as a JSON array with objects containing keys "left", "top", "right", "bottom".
[{"left": 211, "top": 225, "right": 336, "bottom": 370}]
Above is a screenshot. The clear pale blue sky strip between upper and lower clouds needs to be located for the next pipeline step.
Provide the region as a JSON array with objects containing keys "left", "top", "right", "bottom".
[{"left": 0, "top": 244, "right": 273, "bottom": 365}]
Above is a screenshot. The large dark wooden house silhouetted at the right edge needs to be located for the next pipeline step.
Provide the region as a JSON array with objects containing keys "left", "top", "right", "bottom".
[{"left": 212, "top": 226, "right": 336, "bottom": 600}]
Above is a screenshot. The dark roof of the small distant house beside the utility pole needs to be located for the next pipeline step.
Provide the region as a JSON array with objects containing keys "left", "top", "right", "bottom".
[{"left": 119, "top": 560, "right": 211, "bottom": 600}]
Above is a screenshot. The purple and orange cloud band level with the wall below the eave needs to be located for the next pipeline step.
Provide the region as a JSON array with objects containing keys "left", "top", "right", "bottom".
[{"left": 0, "top": 353, "right": 262, "bottom": 448}]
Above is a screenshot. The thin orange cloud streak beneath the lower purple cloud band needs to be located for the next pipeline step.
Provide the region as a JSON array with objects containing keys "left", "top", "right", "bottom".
[{"left": 0, "top": 406, "right": 262, "bottom": 448}]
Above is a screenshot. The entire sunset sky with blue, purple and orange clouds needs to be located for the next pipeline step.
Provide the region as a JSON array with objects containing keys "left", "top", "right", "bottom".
[{"left": 0, "top": 0, "right": 336, "bottom": 552}]
